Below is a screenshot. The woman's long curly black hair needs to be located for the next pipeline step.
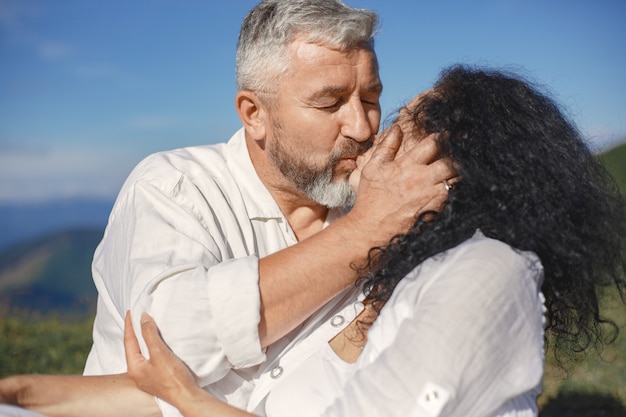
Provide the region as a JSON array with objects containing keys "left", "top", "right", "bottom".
[{"left": 364, "top": 65, "right": 626, "bottom": 360}]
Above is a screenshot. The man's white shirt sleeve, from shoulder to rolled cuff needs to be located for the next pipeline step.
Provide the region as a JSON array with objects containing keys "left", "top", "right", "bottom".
[{"left": 85, "top": 162, "right": 265, "bottom": 386}]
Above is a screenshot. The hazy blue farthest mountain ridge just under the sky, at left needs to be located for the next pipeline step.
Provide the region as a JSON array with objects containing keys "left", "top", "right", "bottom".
[{"left": 0, "top": 199, "right": 113, "bottom": 250}]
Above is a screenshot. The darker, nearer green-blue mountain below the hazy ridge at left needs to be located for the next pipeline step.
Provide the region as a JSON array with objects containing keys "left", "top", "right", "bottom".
[{"left": 0, "top": 229, "right": 103, "bottom": 315}]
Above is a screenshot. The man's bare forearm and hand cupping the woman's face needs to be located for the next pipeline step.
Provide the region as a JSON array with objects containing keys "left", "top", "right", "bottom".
[{"left": 259, "top": 128, "right": 455, "bottom": 346}]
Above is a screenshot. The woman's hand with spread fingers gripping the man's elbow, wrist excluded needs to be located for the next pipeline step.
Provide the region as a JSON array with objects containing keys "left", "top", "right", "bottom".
[{"left": 124, "top": 312, "right": 199, "bottom": 405}]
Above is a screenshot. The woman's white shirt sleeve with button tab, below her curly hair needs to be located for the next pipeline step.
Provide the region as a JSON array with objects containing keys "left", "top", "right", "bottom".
[{"left": 324, "top": 241, "right": 544, "bottom": 417}]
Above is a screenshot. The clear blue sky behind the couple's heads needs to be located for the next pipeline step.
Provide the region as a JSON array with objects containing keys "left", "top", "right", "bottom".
[{"left": 0, "top": 0, "right": 626, "bottom": 203}]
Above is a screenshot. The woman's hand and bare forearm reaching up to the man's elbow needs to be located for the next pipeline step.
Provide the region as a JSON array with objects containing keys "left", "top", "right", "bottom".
[{"left": 124, "top": 313, "right": 254, "bottom": 417}]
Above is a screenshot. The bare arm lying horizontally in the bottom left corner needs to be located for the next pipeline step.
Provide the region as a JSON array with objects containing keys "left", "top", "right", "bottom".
[{"left": 0, "top": 374, "right": 161, "bottom": 417}]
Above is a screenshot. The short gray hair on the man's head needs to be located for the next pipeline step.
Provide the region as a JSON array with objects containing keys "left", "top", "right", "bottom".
[{"left": 237, "top": 0, "right": 378, "bottom": 104}]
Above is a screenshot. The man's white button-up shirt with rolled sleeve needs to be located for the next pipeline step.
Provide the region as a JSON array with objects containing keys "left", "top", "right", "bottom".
[{"left": 84, "top": 129, "right": 341, "bottom": 415}]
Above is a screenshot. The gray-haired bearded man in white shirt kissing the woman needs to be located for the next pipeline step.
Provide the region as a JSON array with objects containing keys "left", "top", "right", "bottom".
[{"left": 0, "top": 0, "right": 454, "bottom": 416}]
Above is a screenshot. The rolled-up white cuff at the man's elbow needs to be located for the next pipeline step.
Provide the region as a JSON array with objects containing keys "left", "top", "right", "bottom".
[{"left": 208, "top": 256, "right": 265, "bottom": 368}]
